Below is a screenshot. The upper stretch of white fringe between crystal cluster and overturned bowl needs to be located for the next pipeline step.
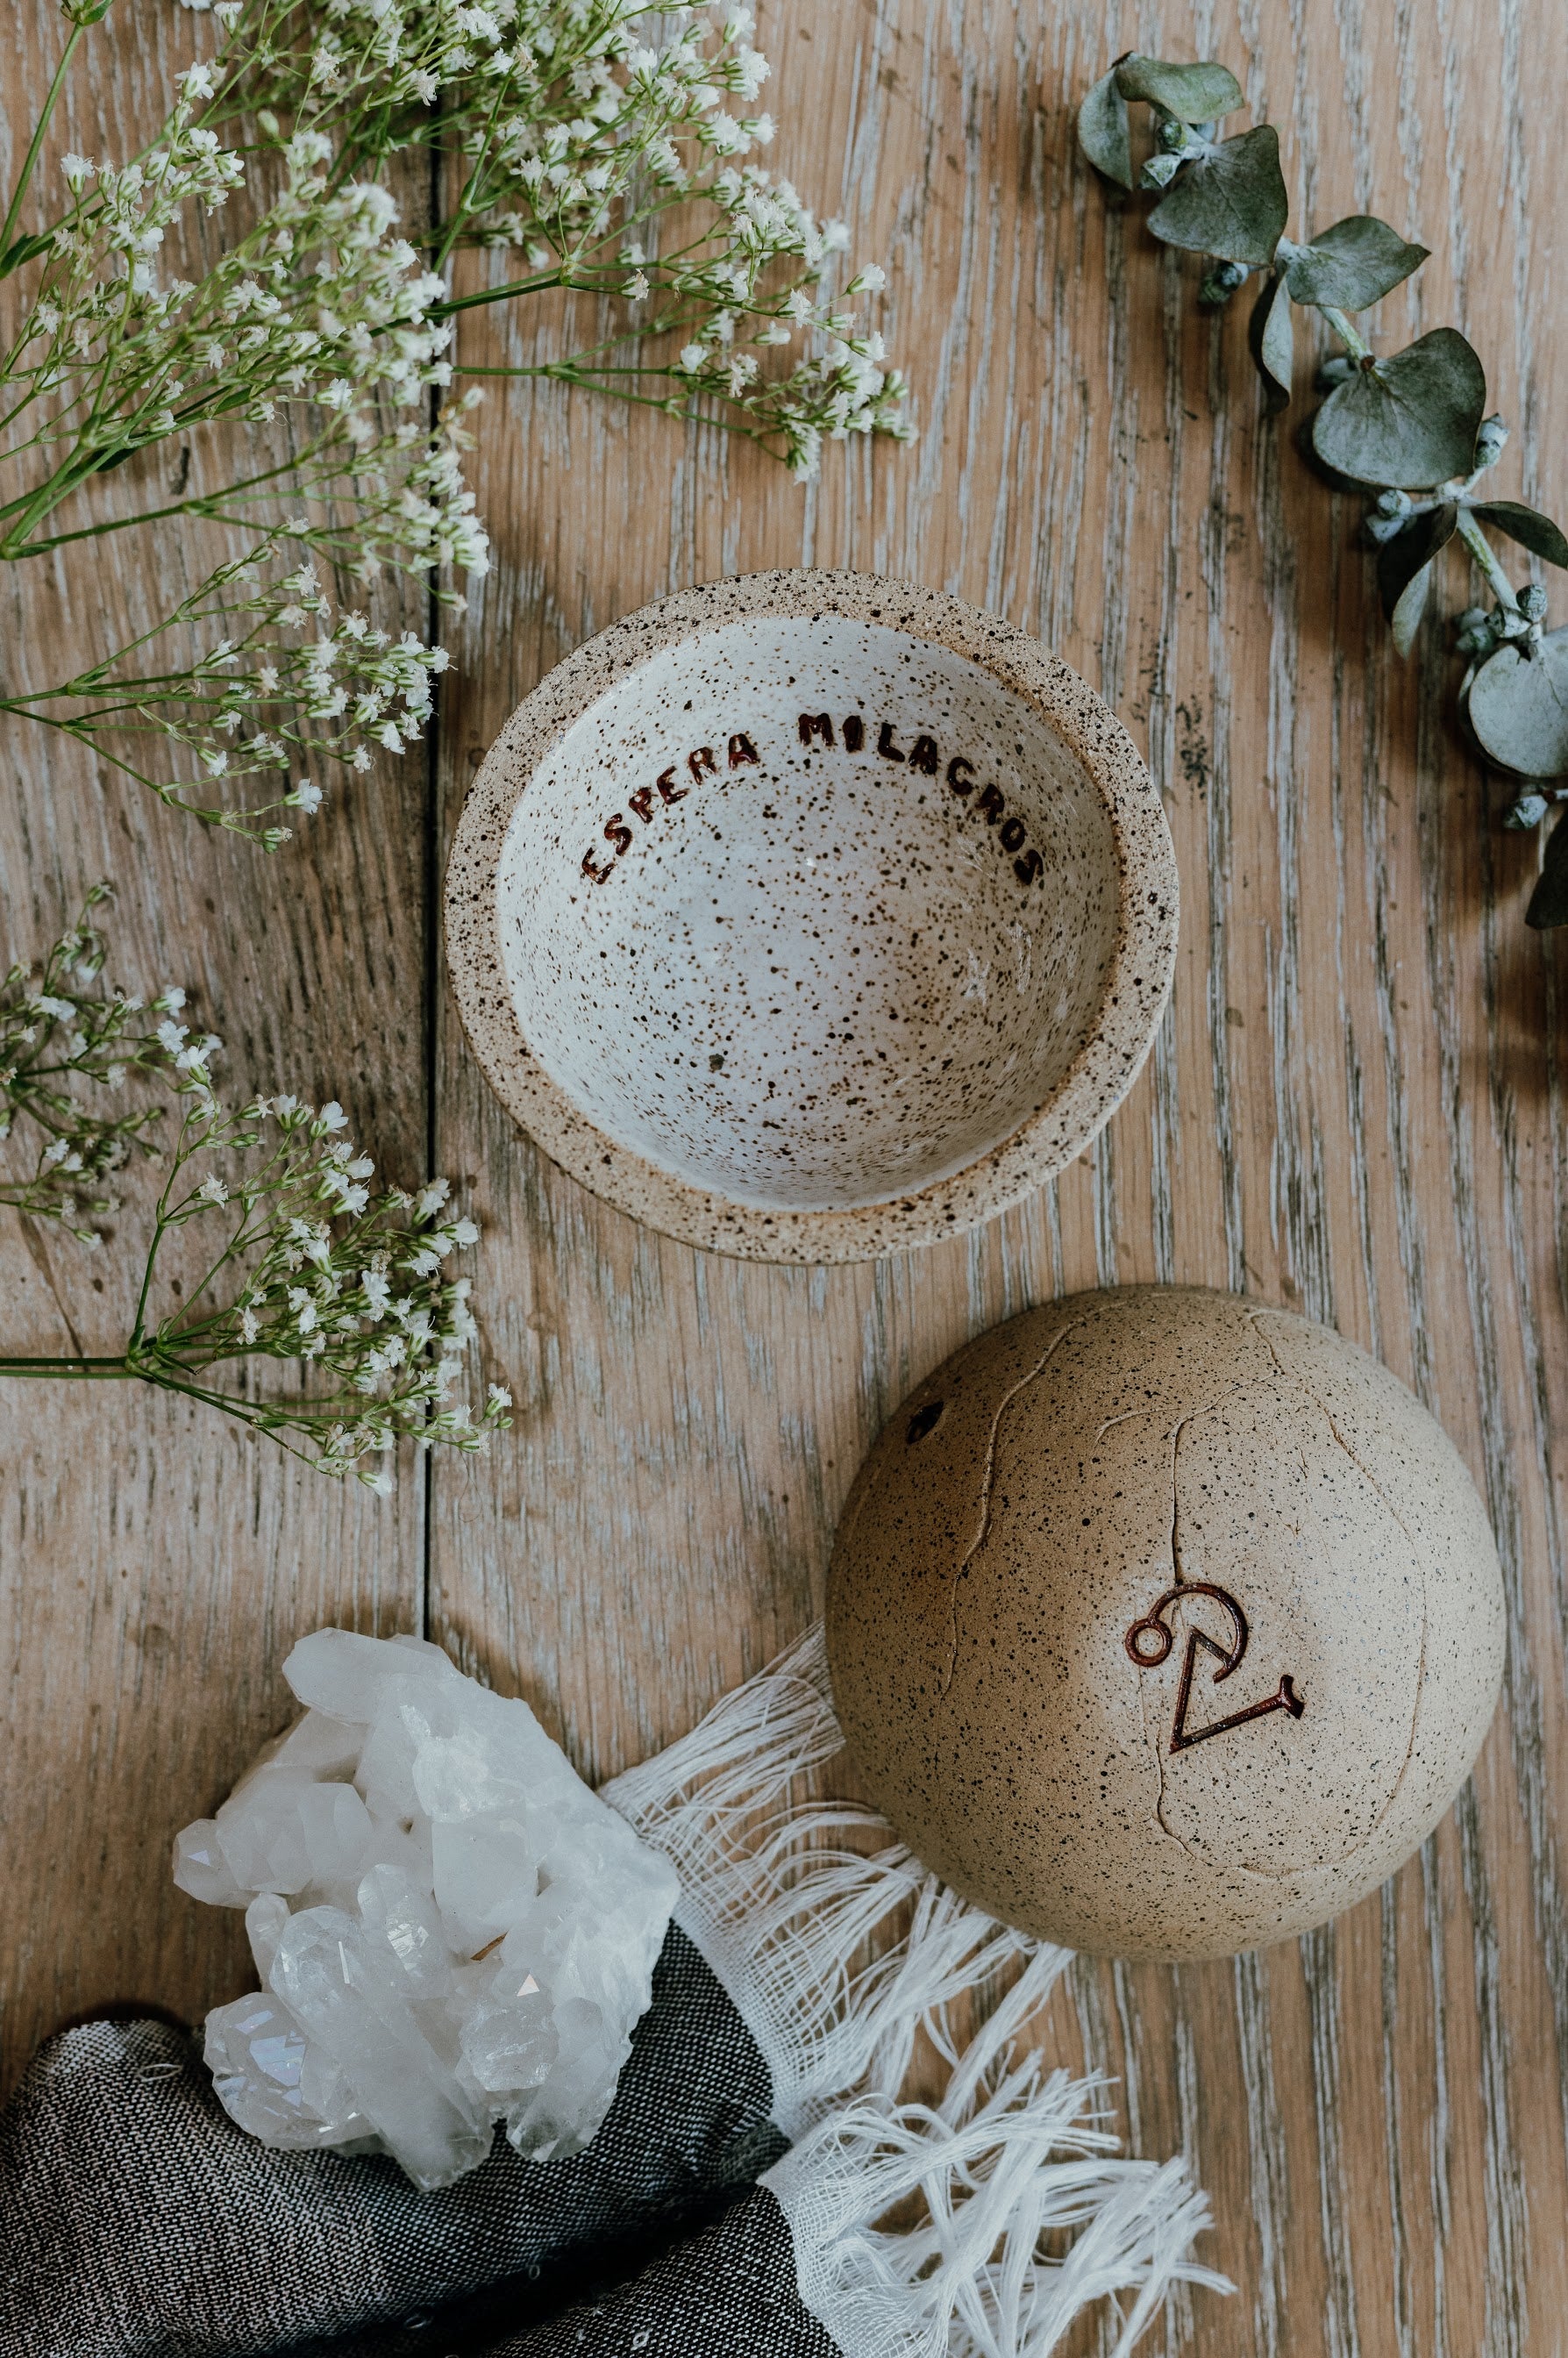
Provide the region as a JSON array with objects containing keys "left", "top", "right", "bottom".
[{"left": 603, "top": 1625, "right": 1046, "bottom": 2136}]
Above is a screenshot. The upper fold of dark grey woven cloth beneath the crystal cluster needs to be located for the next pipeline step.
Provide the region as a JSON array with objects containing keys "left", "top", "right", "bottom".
[{"left": 0, "top": 1926, "right": 785, "bottom": 2358}]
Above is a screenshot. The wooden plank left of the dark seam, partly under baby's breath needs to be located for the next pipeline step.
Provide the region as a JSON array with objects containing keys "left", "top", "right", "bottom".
[{"left": 0, "top": 0, "right": 429, "bottom": 2083}]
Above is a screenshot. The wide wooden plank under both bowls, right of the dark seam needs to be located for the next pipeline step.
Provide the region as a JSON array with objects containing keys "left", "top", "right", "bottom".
[{"left": 431, "top": 0, "right": 1568, "bottom": 2358}]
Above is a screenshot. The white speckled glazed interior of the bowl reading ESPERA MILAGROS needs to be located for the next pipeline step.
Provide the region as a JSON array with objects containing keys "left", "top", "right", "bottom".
[{"left": 497, "top": 613, "right": 1117, "bottom": 1212}]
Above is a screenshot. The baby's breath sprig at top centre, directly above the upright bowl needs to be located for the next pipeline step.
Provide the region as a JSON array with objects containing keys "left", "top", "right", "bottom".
[{"left": 422, "top": 0, "right": 910, "bottom": 481}]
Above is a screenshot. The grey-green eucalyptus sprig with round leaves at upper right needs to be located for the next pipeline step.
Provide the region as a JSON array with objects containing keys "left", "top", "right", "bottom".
[{"left": 1078, "top": 49, "right": 1568, "bottom": 926}]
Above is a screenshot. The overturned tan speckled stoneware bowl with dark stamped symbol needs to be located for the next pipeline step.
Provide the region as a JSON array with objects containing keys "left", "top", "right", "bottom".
[{"left": 828, "top": 1288, "right": 1504, "bottom": 1957}]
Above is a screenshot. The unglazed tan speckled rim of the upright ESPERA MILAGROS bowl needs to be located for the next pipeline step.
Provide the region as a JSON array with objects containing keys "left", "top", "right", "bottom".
[{"left": 445, "top": 568, "right": 1179, "bottom": 1264}]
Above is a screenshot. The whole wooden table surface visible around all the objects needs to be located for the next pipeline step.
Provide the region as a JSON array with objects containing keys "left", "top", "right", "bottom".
[{"left": 0, "top": 0, "right": 1568, "bottom": 2358}]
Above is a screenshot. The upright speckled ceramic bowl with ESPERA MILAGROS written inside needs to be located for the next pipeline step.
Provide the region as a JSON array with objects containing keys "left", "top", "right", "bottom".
[{"left": 445, "top": 573, "right": 1177, "bottom": 1261}]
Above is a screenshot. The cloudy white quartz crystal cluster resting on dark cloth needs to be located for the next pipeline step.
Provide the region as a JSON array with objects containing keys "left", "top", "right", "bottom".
[{"left": 175, "top": 1629, "right": 677, "bottom": 2186}]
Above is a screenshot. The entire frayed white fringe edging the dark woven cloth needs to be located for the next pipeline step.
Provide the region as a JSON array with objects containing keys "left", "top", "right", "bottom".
[{"left": 603, "top": 1625, "right": 1231, "bottom": 2358}]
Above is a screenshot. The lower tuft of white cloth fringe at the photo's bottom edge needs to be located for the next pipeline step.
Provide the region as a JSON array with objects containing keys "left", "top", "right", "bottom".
[{"left": 761, "top": 2042, "right": 1231, "bottom": 2358}]
